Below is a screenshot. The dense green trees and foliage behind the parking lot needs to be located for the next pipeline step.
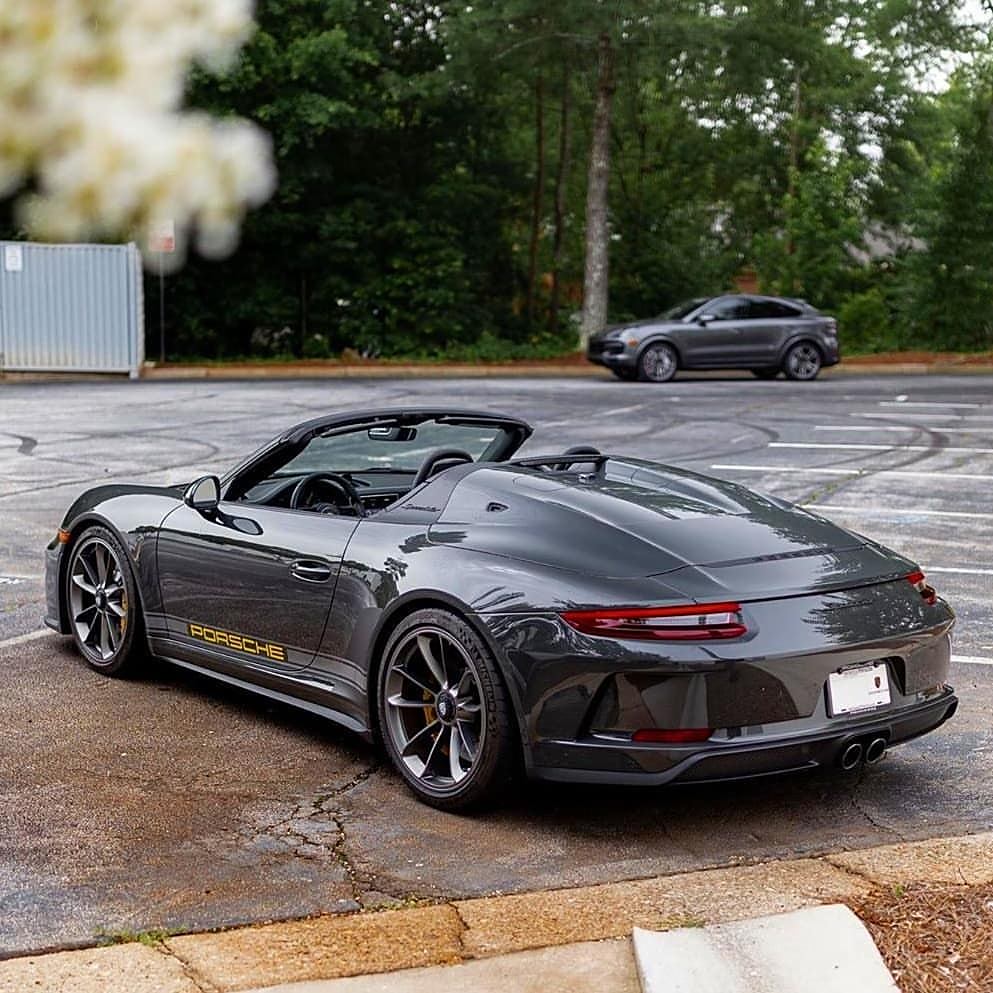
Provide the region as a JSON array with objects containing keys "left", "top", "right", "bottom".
[{"left": 148, "top": 0, "right": 993, "bottom": 358}]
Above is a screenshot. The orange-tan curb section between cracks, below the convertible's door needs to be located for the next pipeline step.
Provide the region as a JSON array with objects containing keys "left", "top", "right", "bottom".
[{"left": 165, "top": 904, "right": 462, "bottom": 993}]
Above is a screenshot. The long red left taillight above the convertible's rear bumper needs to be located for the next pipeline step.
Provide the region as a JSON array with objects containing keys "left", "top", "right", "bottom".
[{"left": 562, "top": 603, "right": 748, "bottom": 641}]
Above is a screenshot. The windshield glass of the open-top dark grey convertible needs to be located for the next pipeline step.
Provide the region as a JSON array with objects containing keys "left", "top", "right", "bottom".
[{"left": 278, "top": 421, "right": 504, "bottom": 476}]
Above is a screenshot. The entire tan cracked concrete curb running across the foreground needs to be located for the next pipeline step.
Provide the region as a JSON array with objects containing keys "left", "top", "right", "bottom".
[{"left": 0, "top": 832, "right": 993, "bottom": 993}]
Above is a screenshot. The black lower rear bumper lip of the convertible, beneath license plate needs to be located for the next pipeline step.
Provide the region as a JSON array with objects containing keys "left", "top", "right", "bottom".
[{"left": 531, "top": 687, "right": 958, "bottom": 786}]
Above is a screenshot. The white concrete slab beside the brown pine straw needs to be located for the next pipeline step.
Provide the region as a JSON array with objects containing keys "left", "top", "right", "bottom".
[{"left": 633, "top": 904, "right": 899, "bottom": 993}]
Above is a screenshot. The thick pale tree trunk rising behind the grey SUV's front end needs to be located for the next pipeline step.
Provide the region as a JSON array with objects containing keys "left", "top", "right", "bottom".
[{"left": 580, "top": 32, "right": 614, "bottom": 347}]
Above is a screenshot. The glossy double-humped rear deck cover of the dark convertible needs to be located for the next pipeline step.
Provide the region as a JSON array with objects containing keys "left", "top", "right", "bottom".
[{"left": 430, "top": 459, "right": 906, "bottom": 599}]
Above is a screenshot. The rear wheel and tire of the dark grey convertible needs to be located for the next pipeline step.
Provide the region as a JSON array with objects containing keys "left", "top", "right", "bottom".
[{"left": 376, "top": 608, "right": 519, "bottom": 811}]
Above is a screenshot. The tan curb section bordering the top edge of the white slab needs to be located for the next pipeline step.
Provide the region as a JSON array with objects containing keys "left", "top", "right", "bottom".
[{"left": 455, "top": 859, "right": 871, "bottom": 956}]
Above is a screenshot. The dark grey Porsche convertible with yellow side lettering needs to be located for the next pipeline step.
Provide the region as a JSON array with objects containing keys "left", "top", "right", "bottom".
[{"left": 46, "top": 409, "right": 957, "bottom": 810}]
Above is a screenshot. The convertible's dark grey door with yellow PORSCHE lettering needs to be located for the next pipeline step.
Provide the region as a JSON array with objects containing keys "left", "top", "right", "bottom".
[{"left": 157, "top": 501, "right": 358, "bottom": 672}]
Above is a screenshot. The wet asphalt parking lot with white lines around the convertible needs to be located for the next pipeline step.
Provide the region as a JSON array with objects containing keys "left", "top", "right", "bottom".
[{"left": 0, "top": 374, "right": 993, "bottom": 956}]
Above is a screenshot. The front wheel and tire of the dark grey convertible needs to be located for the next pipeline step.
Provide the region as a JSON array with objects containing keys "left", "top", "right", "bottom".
[{"left": 65, "top": 527, "right": 148, "bottom": 676}]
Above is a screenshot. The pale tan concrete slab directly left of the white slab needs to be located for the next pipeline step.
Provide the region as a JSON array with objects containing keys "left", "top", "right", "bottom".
[{"left": 244, "top": 938, "right": 641, "bottom": 993}]
